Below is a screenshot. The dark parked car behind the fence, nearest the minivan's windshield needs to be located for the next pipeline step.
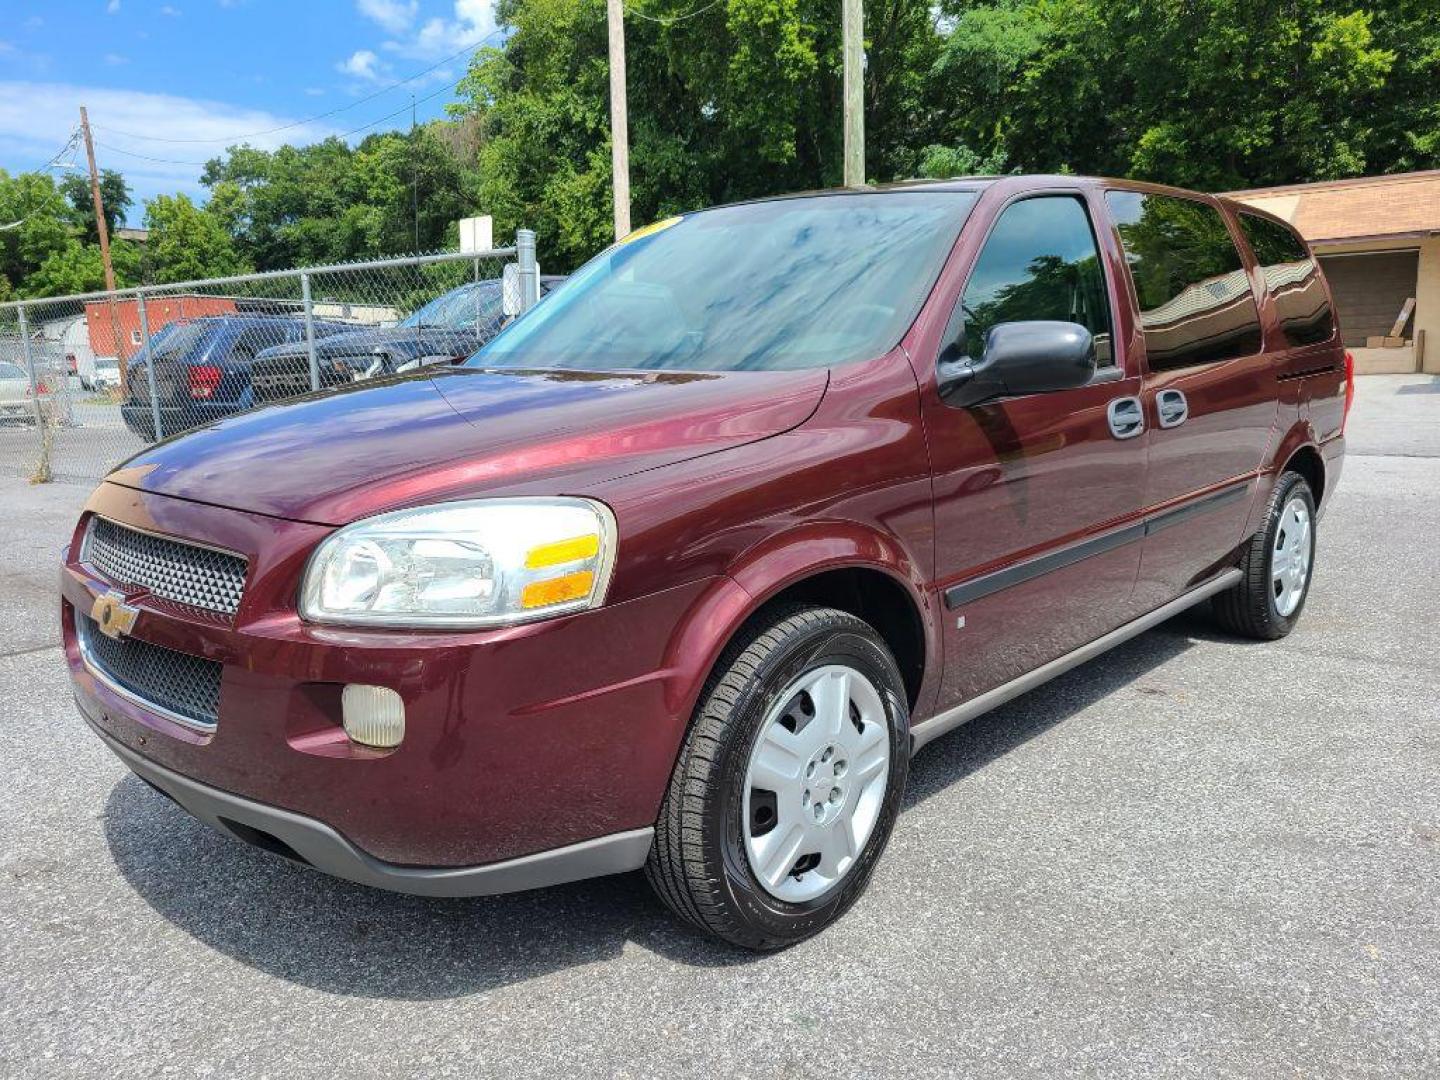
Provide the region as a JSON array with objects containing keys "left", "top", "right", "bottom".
[{"left": 253, "top": 276, "right": 564, "bottom": 402}]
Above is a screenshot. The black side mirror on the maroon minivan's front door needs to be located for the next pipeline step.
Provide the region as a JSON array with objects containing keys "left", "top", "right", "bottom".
[{"left": 940, "top": 320, "right": 1094, "bottom": 406}]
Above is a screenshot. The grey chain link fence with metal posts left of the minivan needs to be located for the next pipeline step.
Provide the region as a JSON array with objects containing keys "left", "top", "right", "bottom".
[{"left": 0, "top": 230, "right": 541, "bottom": 482}]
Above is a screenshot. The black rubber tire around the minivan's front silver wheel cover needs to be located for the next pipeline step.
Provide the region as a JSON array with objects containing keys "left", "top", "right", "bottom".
[{"left": 645, "top": 606, "right": 910, "bottom": 950}]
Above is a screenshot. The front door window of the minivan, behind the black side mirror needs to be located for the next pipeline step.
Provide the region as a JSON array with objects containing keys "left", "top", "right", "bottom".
[{"left": 960, "top": 196, "right": 1115, "bottom": 369}]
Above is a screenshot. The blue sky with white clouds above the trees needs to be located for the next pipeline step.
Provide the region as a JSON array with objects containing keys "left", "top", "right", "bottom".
[{"left": 0, "top": 0, "right": 497, "bottom": 225}]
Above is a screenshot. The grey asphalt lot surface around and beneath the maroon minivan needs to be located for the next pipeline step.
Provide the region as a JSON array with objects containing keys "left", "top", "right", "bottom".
[{"left": 0, "top": 377, "right": 1440, "bottom": 1077}]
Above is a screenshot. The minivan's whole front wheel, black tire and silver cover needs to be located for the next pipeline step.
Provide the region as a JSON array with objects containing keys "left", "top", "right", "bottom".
[{"left": 645, "top": 608, "right": 910, "bottom": 949}]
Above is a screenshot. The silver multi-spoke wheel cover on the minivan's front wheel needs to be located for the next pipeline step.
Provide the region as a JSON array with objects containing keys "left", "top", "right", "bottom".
[{"left": 742, "top": 664, "right": 890, "bottom": 903}]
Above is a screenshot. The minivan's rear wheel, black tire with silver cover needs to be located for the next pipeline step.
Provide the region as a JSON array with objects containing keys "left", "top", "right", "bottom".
[{"left": 1212, "top": 472, "right": 1315, "bottom": 641}]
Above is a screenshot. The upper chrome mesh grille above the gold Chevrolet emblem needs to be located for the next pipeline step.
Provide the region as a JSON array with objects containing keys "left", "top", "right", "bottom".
[{"left": 81, "top": 517, "right": 245, "bottom": 615}]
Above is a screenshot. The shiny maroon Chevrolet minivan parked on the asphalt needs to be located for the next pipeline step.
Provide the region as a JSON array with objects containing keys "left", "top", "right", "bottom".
[{"left": 62, "top": 177, "right": 1352, "bottom": 949}]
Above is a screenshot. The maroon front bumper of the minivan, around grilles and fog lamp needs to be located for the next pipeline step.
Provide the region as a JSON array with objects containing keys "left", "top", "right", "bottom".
[{"left": 60, "top": 482, "right": 725, "bottom": 890}]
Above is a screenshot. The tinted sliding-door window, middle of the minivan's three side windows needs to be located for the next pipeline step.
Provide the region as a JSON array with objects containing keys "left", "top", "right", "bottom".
[{"left": 1106, "top": 192, "right": 1261, "bottom": 372}]
